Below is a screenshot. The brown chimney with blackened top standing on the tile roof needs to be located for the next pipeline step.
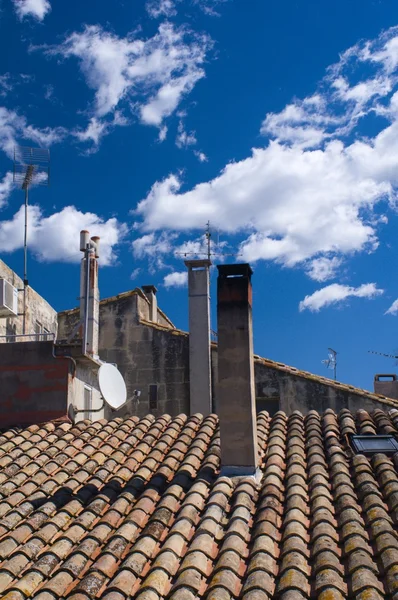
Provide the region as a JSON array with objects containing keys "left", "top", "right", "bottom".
[{"left": 217, "top": 264, "right": 258, "bottom": 477}]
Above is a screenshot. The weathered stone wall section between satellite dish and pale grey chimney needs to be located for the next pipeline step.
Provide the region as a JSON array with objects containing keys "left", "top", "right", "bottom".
[{"left": 58, "top": 292, "right": 189, "bottom": 418}]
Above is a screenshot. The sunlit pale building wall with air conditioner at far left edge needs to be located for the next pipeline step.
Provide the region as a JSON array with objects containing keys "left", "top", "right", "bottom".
[{"left": 0, "top": 260, "right": 58, "bottom": 343}]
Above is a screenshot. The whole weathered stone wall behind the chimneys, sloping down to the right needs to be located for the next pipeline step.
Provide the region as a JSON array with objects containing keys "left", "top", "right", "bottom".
[{"left": 59, "top": 290, "right": 398, "bottom": 418}]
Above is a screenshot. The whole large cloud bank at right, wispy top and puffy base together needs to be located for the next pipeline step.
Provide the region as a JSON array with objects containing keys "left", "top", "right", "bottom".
[{"left": 137, "top": 29, "right": 398, "bottom": 274}]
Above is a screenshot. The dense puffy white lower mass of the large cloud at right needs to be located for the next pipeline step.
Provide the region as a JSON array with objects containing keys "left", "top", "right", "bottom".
[{"left": 138, "top": 139, "right": 388, "bottom": 266}]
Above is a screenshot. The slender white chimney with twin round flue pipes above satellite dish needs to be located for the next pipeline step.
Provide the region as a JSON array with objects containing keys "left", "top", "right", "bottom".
[{"left": 80, "top": 231, "right": 99, "bottom": 357}]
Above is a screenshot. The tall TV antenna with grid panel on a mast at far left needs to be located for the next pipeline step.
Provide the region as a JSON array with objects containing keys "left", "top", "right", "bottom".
[{"left": 13, "top": 146, "right": 50, "bottom": 334}]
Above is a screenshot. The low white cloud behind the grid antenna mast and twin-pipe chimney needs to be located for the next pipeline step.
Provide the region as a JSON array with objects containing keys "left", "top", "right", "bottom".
[{"left": 0, "top": 205, "right": 127, "bottom": 265}]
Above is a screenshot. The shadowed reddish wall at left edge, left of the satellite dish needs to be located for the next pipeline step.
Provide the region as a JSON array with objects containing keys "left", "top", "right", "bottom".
[{"left": 0, "top": 342, "right": 71, "bottom": 429}]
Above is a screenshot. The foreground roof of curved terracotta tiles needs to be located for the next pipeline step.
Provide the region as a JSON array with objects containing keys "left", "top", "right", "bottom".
[{"left": 0, "top": 409, "right": 398, "bottom": 600}]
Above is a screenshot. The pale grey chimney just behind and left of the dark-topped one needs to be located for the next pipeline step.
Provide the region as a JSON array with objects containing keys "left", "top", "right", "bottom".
[{"left": 185, "top": 259, "right": 212, "bottom": 416}]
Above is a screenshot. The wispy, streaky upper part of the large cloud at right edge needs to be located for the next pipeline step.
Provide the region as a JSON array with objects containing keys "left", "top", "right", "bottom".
[{"left": 261, "top": 27, "right": 398, "bottom": 148}]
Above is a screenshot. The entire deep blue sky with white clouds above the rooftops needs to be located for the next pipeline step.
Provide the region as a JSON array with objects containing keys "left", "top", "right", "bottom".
[{"left": 0, "top": 0, "right": 398, "bottom": 389}]
